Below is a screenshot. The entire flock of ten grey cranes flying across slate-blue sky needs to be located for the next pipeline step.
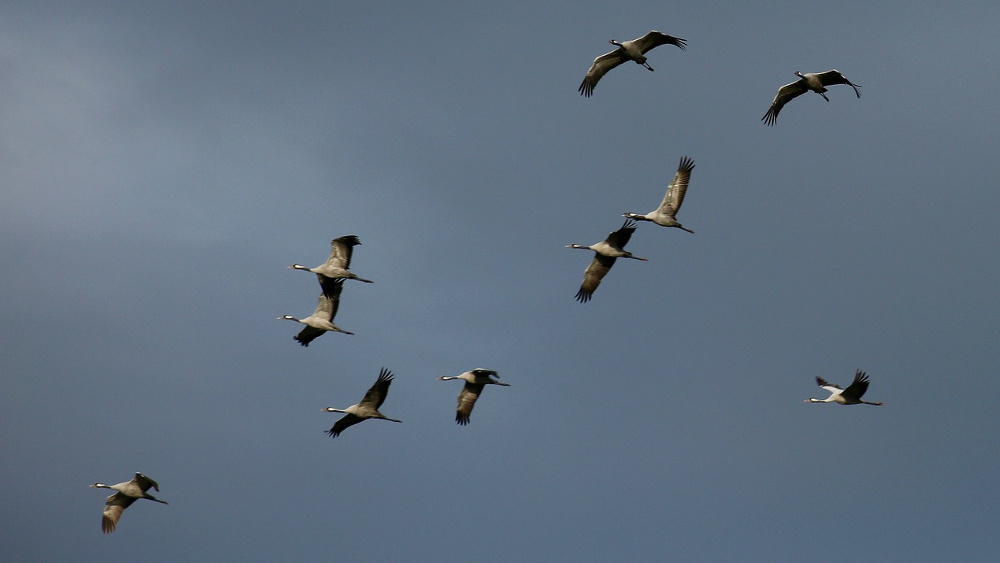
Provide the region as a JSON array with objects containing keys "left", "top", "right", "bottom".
[{"left": 91, "top": 31, "right": 882, "bottom": 534}]
